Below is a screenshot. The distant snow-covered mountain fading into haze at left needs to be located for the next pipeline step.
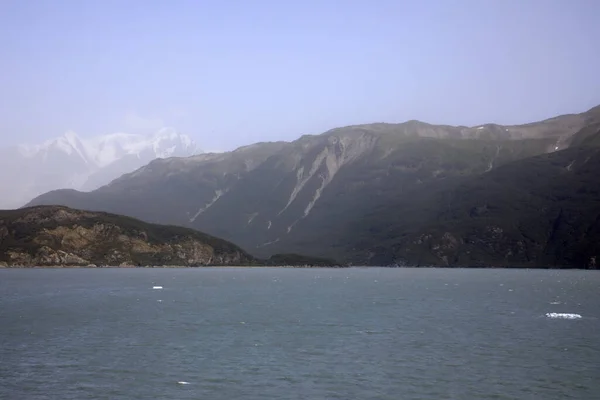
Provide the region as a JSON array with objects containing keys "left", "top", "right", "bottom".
[{"left": 0, "top": 128, "right": 199, "bottom": 209}]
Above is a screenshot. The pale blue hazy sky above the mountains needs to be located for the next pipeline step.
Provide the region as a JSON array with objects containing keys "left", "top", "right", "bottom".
[{"left": 0, "top": 0, "right": 600, "bottom": 150}]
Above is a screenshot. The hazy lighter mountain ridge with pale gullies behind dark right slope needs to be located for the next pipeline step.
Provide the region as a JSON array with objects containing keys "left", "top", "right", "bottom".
[{"left": 23, "top": 107, "right": 600, "bottom": 266}]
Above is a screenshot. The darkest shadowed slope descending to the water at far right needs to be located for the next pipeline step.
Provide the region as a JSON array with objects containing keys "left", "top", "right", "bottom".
[{"left": 338, "top": 147, "right": 600, "bottom": 268}]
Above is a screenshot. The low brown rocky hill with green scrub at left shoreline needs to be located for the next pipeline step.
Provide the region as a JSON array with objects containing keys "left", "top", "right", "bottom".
[{"left": 0, "top": 207, "right": 256, "bottom": 266}]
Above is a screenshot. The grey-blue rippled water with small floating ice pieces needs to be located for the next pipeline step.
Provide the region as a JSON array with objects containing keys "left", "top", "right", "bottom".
[{"left": 0, "top": 268, "right": 600, "bottom": 400}]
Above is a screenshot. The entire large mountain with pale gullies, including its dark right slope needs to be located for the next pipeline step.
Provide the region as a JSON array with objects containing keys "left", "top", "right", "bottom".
[{"left": 24, "top": 107, "right": 600, "bottom": 267}]
